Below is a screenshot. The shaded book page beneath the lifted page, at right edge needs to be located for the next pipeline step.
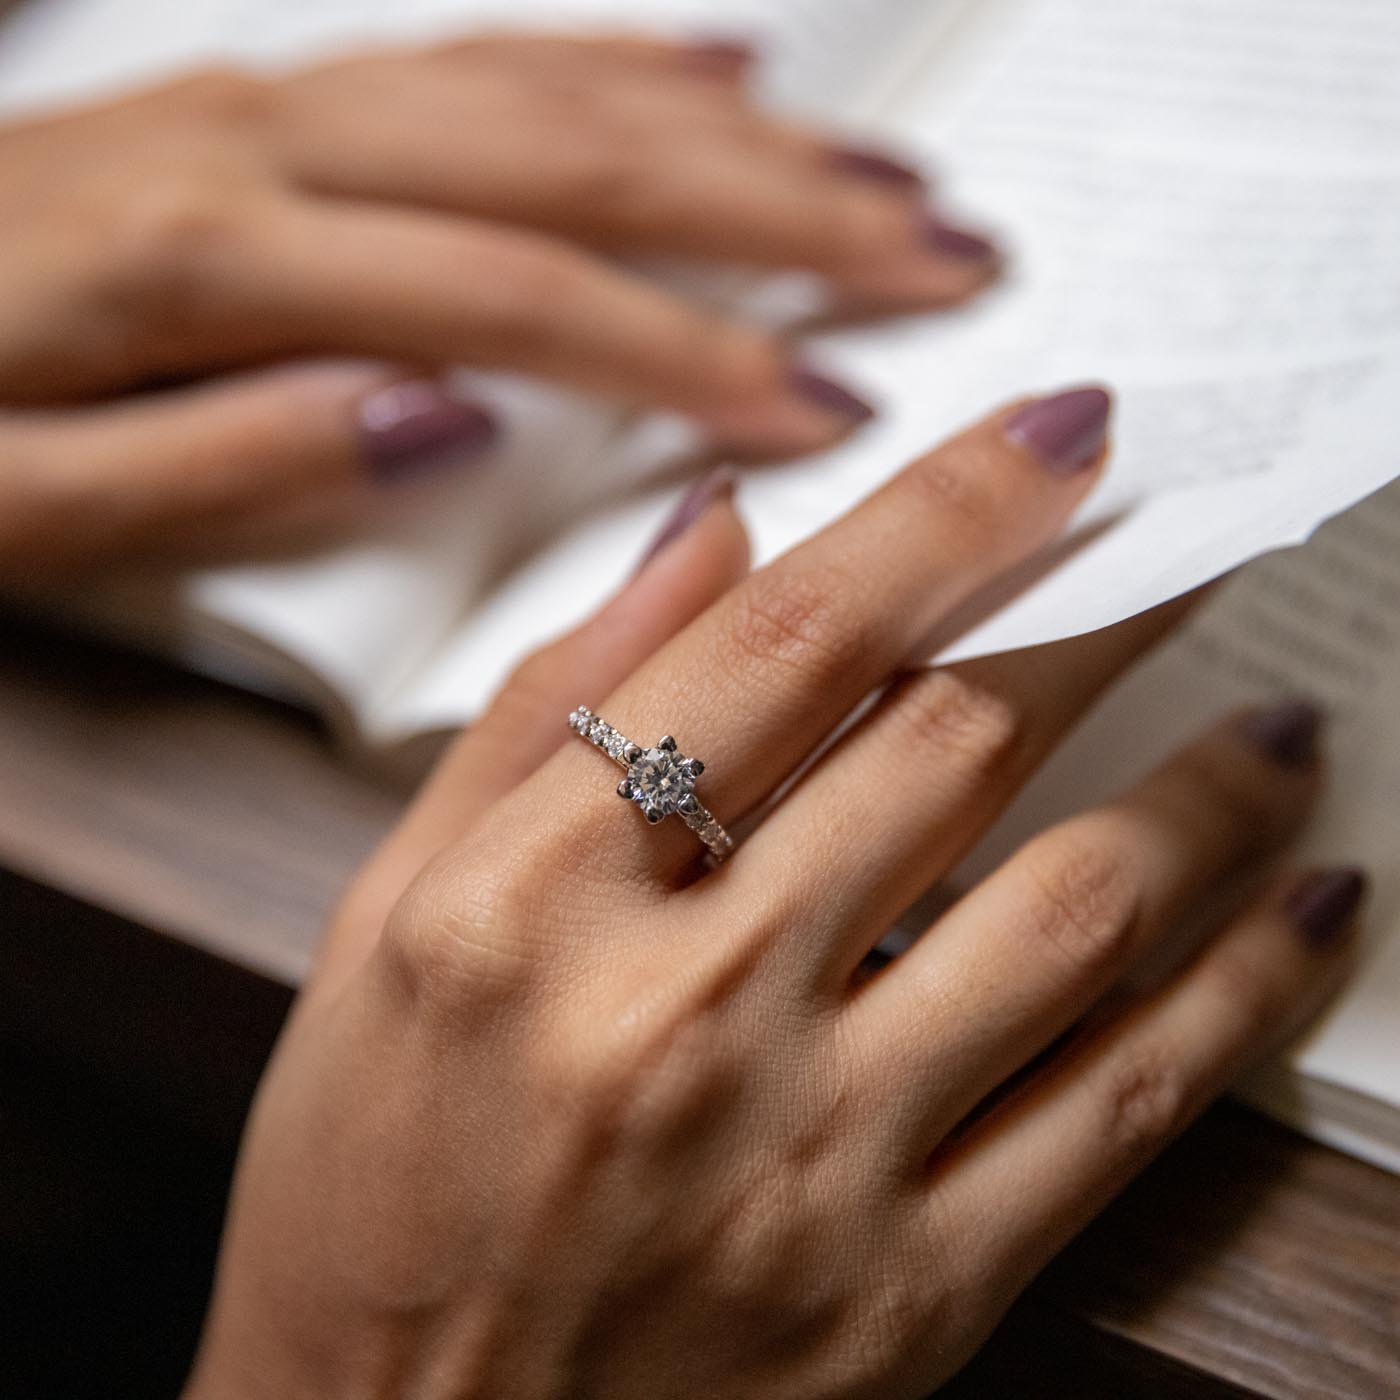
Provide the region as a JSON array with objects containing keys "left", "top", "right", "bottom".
[{"left": 962, "top": 483, "right": 1400, "bottom": 1170}]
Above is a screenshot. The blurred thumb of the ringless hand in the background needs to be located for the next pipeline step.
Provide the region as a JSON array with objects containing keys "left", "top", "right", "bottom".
[{"left": 0, "top": 361, "right": 494, "bottom": 581}]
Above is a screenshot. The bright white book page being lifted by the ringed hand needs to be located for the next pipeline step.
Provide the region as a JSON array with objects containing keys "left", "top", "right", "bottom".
[{"left": 386, "top": 0, "right": 1400, "bottom": 731}]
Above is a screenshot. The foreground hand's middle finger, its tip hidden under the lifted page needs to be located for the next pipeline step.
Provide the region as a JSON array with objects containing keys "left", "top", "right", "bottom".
[{"left": 735, "top": 599, "right": 1193, "bottom": 994}]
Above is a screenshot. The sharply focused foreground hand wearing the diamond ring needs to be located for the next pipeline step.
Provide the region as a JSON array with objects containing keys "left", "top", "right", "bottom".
[{"left": 177, "top": 391, "right": 1362, "bottom": 1400}]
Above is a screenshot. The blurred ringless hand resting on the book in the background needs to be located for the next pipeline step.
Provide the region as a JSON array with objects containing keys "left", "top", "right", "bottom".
[{"left": 0, "top": 38, "right": 995, "bottom": 578}]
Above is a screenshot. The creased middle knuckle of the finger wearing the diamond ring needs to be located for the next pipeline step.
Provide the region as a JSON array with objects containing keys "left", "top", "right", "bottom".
[{"left": 724, "top": 567, "right": 865, "bottom": 683}]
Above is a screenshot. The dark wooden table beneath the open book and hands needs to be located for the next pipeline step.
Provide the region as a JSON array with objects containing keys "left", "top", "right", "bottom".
[{"left": 0, "top": 620, "right": 1400, "bottom": 1400}]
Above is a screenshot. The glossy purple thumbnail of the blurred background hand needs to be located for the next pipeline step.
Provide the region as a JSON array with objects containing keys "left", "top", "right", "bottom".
[{"left": 358, "top": 379, "right": 497, "bottom": 480}]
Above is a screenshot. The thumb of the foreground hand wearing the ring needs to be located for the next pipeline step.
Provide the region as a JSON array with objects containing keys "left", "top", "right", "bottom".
[{"left": 312, "top": 468, "right": 749, "bottom": 994}]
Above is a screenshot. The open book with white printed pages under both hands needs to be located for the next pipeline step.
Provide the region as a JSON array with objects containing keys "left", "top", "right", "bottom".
[{"left": 0, "top": 0, "right": 1400, "bottom": 1169}]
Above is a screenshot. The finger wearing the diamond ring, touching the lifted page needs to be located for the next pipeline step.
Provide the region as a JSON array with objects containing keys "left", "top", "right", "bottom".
[{"left": 554, "top": 389, "right": 1109, "bottom": 881}]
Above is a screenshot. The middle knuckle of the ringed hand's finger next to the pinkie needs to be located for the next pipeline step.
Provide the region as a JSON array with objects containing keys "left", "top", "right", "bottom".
[{"left": 1022, "top": 819, "right": 1141, "bottom": 980}]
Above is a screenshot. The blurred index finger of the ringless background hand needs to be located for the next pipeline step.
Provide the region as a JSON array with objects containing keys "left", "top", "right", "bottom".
[{"left": 239, "top": 200, "right": 874, "bottom": 456}]
